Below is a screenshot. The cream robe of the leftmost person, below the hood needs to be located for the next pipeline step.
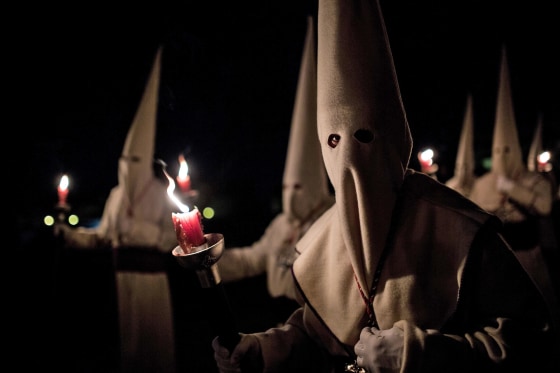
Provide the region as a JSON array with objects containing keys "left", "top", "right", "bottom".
[{"left": 64, "top": 178, "right": 177, "bottom": 373}]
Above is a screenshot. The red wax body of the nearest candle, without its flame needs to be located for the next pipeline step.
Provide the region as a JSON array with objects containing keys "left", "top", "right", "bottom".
[{"left": 172, "top": 208, "right": 206, "bottom": 254}]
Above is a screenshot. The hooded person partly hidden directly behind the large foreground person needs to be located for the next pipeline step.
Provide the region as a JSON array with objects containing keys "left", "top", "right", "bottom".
[{"left": 219, "top": 17, "right": 334, "bottom": 308}]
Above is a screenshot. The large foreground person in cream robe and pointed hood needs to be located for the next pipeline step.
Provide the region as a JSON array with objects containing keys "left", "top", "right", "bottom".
[{"left": 213, "top": 0, "right": 551, "bottom": 372}]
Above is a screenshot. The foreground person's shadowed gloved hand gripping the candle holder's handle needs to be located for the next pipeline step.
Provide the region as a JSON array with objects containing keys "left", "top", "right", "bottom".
[{"left": 212, "top": 333, "right": 263, "bottom": 373}]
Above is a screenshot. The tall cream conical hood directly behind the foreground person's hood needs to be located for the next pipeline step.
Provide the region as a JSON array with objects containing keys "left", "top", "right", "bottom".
[{"left": 282, "top": 17, "right": 331, "bottom": 221}]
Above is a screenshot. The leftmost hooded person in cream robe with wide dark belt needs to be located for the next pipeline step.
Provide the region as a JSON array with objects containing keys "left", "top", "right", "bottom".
[{"left": 57, "top": 48, "right": 177, "bottom": 373}]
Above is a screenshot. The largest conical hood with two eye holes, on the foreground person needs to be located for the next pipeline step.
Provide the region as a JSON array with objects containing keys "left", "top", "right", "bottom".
[{"left": 317, "top": 0, "right": 412, "bottom": 291}]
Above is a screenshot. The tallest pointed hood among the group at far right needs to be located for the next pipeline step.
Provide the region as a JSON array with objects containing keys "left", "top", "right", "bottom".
[{"left": 492, "top": 47, "right": 525, "bottom": 178}]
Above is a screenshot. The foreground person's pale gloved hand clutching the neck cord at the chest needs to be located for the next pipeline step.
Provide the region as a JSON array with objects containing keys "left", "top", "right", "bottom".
[{"left": 354, "top": 327, "right": 404, "bottom": 373}]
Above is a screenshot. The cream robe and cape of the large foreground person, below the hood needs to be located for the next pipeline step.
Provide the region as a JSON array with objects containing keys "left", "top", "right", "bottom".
[{"left": 247, "top": 171, "right": 557, "bottom": 372}]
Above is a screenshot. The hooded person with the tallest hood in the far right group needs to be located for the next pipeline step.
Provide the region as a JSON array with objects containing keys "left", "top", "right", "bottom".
[{"left": 470, "top": 47, "right": 560, "bottom": 334}]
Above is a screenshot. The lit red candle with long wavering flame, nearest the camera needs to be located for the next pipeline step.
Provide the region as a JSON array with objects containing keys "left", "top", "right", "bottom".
[{"left": 164, "top": 170, "right": 206, "bottom": 254}]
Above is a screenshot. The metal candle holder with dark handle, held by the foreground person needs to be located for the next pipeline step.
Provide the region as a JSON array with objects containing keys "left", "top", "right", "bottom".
[{"left": 172, "top": 233, "right": 241, "bottom": 351}]
